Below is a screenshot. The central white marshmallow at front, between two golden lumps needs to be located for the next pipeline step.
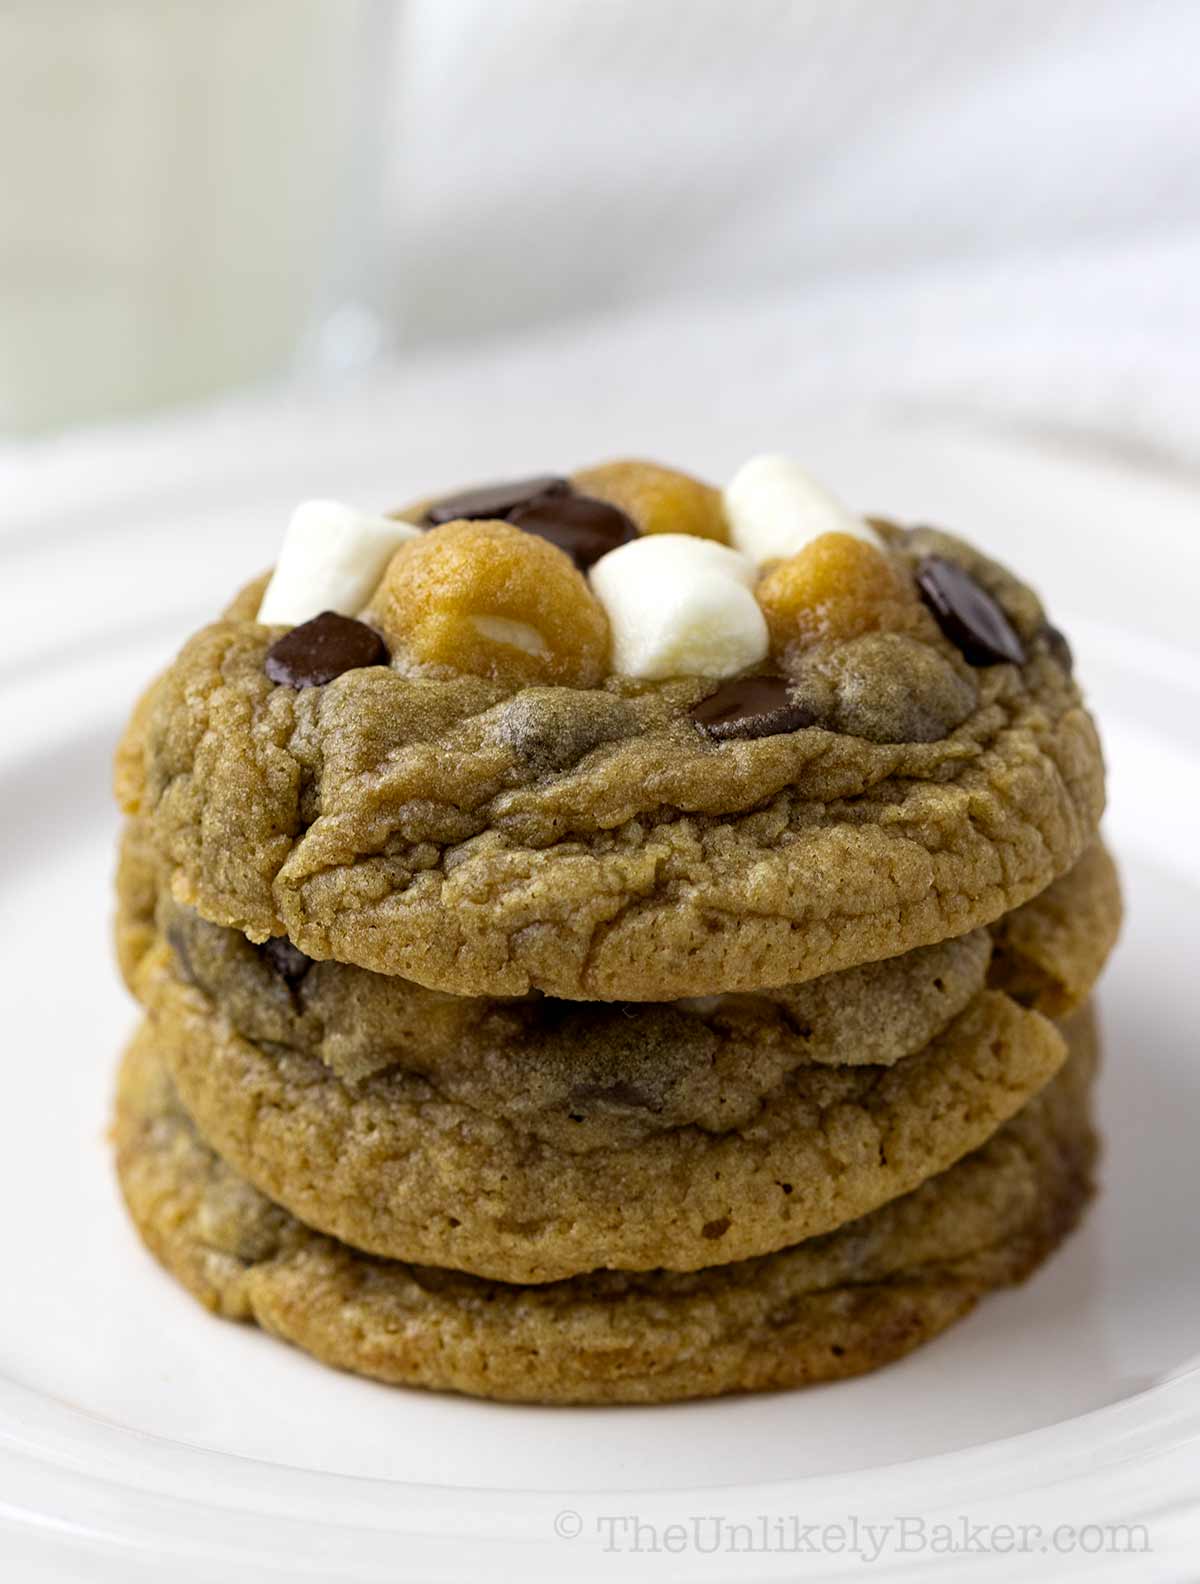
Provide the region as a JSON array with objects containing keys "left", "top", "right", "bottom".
[{"left": 591, "top": 534, "right": 768, "bottom": 681}]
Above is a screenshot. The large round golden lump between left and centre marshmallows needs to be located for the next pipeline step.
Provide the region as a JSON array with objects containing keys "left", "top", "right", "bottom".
[{"left": 369, "top": 521, "right": 608, "bottom": 687}]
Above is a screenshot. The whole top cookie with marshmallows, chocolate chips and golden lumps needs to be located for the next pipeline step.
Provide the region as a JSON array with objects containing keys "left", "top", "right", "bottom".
[{"left": 117, "top": 458, "right": 1103, "bottom": 1001}]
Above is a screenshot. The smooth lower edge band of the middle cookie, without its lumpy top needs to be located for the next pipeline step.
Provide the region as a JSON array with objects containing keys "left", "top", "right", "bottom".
[{"left": 131, "top": 918, "right": 1064, "bottom": 1281}]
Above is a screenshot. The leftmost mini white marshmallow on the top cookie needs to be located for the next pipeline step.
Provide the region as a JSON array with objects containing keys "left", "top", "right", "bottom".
[{"left": 258, "top": 501, "right": 421, "bottom": 627}]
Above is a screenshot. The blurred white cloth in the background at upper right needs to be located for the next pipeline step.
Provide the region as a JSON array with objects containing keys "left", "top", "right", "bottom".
[{"left": 388, "top": 0, "right": 1200, "bottom": 466}]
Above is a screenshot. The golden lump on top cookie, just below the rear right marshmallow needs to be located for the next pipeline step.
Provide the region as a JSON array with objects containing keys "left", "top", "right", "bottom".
[{"left": 755, "top": 534, "right": 920, "bottom": 654}]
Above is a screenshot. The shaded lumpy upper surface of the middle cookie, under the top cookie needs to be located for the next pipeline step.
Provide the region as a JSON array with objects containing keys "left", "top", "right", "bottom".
[{"left": 117, "top": 822, "right": 1121, "bottom": 1108}]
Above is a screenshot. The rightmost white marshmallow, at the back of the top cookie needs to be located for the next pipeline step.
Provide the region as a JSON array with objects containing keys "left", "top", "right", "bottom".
[{"left": 725, "top": 456, "right": 879, "bottom": 565}]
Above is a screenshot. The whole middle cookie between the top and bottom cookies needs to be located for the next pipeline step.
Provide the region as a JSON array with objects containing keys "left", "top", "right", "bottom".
[{"left": 119, "top": 832, "right": 1119, "bottom": 1281}]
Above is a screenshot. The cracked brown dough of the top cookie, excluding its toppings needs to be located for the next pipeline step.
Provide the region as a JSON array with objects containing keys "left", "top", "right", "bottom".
[{"left": 117, "top": 510, "right": 1103, "bottom": 1001}]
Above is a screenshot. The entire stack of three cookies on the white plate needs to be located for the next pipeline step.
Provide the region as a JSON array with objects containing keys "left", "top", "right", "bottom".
[{"left": 114, "top": 456, "right": 1121, "bottom": 1402}]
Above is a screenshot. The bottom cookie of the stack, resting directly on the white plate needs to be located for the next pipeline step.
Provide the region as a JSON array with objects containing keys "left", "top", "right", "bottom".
[{"left": 114, "top": 1011, "right": 1096, "bottom": 1403}]
